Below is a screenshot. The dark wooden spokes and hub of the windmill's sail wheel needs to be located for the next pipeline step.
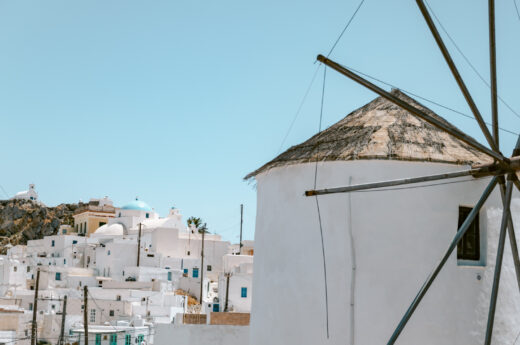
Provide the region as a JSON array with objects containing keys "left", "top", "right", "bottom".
[{"left": 305, "top": 0, "right": 520, "bottom": 345}]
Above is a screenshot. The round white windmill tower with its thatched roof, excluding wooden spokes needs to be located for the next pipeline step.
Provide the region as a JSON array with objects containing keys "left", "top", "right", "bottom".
[{"left": 247, "top": 90, "right": 520, "bottom": 345}]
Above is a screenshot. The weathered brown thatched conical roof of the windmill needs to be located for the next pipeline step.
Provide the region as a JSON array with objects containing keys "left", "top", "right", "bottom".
[{"left": 245, "top": 89, "right": 493, "bottom": 179}]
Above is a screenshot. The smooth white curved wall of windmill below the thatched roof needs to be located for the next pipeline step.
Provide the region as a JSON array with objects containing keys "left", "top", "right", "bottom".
[{"left": 251, "top": 161, "right": 520, "bottom": 345}]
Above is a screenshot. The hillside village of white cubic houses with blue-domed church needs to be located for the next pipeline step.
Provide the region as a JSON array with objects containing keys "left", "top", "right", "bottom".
[{"left": 0, "top": 185, "right": 254, "bottom": 345}]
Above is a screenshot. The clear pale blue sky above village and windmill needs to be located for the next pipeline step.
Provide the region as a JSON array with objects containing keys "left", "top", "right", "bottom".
[{"left": 0, "top": 0, "right": 520, "bottom": 241}]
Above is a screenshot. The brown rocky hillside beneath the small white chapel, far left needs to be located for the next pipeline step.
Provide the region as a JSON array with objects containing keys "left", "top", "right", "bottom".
[{"left": 0, "top": 200, "right": 79, "bottom": 254}]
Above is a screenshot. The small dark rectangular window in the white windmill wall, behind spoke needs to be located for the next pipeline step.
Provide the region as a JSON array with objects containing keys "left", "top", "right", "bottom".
[{"left": 457, "top": 206, "right": 480, "bottom": 261}]
